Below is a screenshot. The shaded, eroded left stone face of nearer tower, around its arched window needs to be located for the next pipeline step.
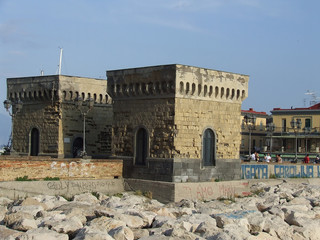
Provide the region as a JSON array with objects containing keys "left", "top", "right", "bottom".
[{"left": 113, "top": 99, "right": 174, "bottom": 158}]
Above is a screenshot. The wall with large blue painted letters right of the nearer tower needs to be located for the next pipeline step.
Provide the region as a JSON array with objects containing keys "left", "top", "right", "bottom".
[{"left": 241, "top": 164, "right": 320, "bottom": 179}]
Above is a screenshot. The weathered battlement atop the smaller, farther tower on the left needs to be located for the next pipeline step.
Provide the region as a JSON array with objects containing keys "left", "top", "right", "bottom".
[{"left": 7, "top": 75, "right": 111, "bottom": 104}]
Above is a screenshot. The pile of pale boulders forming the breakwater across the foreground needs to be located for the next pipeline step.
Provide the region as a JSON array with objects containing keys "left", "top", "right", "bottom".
[{"left": 0, "top": 180, "right": 320, "bottom": 240}]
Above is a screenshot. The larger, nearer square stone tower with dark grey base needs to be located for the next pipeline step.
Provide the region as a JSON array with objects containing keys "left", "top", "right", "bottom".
[{"left": 107, "top": 64, "right": 249, "bottom": 182}]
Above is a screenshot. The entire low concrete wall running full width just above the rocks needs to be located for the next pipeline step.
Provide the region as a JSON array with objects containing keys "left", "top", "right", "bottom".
[{"left": 0, "top": 178, "right": 320, "bottom": 203}]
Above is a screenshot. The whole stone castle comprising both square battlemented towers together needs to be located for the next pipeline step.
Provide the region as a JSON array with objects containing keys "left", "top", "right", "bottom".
[{"left": 7, "top": 64, "right": 249, "bottom": 182}]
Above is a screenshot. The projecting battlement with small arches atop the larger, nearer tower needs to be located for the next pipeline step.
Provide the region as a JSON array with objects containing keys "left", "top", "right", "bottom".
[{"left": 107, "top": 65, "right": 249, "bottom": 102}]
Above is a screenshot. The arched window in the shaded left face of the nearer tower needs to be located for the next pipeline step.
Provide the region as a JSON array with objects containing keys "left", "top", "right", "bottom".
[{"left": 135, "top": 128, "right": 148, "bottom": 165}]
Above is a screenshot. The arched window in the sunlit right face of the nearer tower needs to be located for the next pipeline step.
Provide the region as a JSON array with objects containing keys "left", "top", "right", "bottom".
[{"left": 202, "top": 129, "right": 216, "bottom": 167}]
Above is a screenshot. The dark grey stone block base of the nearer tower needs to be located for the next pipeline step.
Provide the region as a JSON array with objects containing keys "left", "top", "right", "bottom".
[{"left": 123, "top": 158, "right": 241, "bottom": 183}]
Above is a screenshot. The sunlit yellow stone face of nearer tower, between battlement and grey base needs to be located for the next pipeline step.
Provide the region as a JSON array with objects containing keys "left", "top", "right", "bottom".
[{"left": 174, "top": 98, "right": 241, "bottom": 159}]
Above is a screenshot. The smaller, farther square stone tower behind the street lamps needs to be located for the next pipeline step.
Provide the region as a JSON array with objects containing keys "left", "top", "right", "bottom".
[{"left": 7, "top": 75, "right": 112, "bottom": 157}]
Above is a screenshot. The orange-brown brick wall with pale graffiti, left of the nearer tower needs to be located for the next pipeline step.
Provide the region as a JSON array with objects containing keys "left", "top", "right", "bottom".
[{"left": 0, "top": 156, "right": 123, "bottom": 181}]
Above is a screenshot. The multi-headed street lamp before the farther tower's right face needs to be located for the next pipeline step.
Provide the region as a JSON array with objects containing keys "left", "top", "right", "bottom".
[{"left": 75, "top": 97, "right": 94, "bottom": 158}]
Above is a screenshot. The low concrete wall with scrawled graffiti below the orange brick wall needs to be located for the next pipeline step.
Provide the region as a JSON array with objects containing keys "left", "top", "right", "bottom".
[{"left": 0, "top": 179, "right": 124, "bottom": 199}]
